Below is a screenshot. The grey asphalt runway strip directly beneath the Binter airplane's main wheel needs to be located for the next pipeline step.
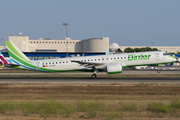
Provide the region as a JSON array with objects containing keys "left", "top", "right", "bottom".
[{"left": 0, "top": 77, "right": 180, "bottom": 85}]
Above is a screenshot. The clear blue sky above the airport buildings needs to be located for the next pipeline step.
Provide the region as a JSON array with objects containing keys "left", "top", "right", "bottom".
[{"left": 0, "top": 0, "right": 180, "bottom": 46}]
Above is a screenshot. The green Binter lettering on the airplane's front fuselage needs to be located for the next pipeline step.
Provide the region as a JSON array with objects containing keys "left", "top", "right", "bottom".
[{"left": 128, "top": 54, "right": 151, "bottom": 61}]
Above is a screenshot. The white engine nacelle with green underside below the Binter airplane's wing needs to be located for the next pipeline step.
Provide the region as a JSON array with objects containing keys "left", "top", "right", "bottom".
[{"left": 105, "top": 63, "right": 122, "bottom": 74}]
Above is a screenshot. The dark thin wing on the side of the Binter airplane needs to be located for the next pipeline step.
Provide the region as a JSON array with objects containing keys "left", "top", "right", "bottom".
[{"left": 71, "top": 60, "right": 105, "bottom": 67}]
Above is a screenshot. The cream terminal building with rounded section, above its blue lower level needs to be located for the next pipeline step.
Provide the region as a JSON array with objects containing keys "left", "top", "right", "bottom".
[{"left": 9, "top": 36, "right": 109, "bottom": 53}]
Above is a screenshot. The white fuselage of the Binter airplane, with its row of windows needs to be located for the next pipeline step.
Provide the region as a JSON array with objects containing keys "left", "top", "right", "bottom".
[{"left": 31, "top": 51, "right": 176, "bottom": 70}]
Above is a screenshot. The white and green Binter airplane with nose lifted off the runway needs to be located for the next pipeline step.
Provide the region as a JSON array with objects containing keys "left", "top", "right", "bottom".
[{"left": 5, "top": 41, "right": 176, "bottom": 78}]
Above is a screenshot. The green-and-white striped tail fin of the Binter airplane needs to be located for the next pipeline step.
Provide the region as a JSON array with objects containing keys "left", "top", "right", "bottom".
[{"left": 5, "top": 41, "right": 30, "bottom": 64}]
